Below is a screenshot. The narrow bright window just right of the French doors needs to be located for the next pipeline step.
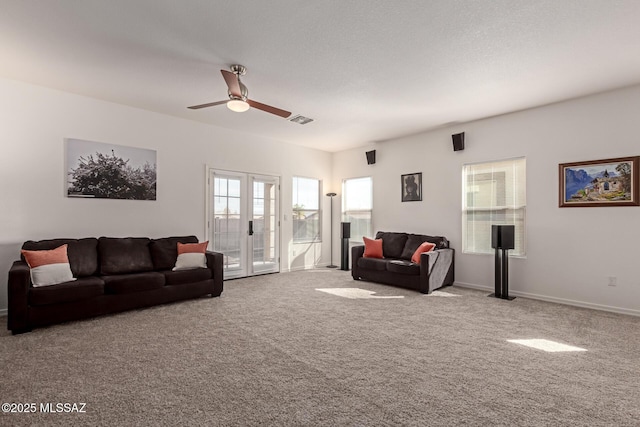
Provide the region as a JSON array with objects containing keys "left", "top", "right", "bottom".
[{"left": 292, "top": 176, "right": 320, "bottom": 243}]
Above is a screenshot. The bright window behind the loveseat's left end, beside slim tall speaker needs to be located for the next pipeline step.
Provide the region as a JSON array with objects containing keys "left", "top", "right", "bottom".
[{"left": 342, "top": 177, "right": 373, "bottom": 242}]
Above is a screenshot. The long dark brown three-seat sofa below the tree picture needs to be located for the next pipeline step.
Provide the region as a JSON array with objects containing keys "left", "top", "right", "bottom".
[{"left": 7, "top": 236, "right": 223, "bottom": 334}]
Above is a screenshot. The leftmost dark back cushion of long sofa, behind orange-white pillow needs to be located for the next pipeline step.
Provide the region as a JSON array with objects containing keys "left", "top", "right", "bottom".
[{"left": 22, "top": 237, "right": 98, "bottom": 277}]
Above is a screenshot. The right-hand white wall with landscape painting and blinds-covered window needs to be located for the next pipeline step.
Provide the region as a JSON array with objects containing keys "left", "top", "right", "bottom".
[{"left": 333, "top": 86, "right": 640, "bottom": 315}]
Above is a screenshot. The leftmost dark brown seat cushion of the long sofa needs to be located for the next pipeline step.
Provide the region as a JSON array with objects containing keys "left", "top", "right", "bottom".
[{"left": 29, "top": 277, "right": 104, "bottom": 305}]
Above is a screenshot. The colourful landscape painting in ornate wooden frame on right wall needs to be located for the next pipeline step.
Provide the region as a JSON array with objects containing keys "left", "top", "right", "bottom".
[{"left": 559, "top": 156, "right": 640, "bottom": 208}]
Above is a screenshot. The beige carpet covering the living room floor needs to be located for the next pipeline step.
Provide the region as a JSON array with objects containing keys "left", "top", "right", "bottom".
[{"left": 0, "top": 269, "right": 640, "bottom": 426}]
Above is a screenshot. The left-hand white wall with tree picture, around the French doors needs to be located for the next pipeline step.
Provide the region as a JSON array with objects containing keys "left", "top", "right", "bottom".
[{"left": 0, "top": 79, "right": 331, "bottom": 312}]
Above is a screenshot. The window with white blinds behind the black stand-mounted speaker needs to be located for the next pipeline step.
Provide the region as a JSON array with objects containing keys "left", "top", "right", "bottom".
[{"left": 462, "top": 158, "right": 527, "bottom": 256}]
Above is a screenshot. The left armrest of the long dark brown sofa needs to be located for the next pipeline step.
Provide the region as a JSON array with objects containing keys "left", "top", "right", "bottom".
[{"left": 7, "top": 261, "right": 31, "bottom": 334}]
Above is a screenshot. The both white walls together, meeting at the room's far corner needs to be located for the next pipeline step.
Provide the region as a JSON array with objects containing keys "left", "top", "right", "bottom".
[{"left": 5, "top": 79, "right": 640, "bottom": 315}]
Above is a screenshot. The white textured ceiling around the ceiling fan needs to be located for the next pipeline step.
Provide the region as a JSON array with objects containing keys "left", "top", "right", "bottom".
[{"left": 0, "top": 0, "right": 640, "bottom": 151}]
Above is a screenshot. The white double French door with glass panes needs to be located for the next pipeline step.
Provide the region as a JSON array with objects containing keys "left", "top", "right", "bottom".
[{"left": 207, "top": 170, "right": 280, "bottom": 279}]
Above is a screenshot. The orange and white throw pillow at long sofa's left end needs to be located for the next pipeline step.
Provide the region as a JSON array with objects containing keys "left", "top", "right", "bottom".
[{"left": 20, "top": 245, "right": 76, "bottom": 287}]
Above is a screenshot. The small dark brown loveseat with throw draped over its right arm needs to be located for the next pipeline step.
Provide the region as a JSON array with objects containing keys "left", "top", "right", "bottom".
[{"left": 351, "top": 231, "right": 454, "bottom": 294}]
